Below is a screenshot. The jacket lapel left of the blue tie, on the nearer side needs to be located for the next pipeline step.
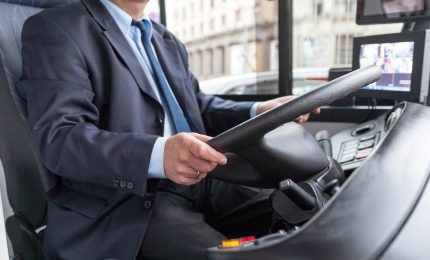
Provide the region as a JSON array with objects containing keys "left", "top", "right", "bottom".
[{"left": 82, "top": 0, "right": 161, "bottom": 105}]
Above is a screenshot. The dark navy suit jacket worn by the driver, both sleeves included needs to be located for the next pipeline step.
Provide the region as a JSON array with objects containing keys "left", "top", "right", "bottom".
[{"left": 18, "top": 0, "right": 252, "bottom": 259}]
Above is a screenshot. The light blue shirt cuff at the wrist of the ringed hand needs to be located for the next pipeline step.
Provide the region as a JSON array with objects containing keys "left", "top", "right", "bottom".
[{"left": 148, "top": 137, "right": 167, "bottom": 179}]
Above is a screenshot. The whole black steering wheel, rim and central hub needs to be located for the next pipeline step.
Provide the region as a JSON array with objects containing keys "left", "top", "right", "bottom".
[{"left": 208, "top": 66, "right": 381, "bottom": 188}]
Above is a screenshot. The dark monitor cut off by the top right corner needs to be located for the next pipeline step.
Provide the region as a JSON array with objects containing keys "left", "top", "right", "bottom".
[{"left": 356, "top": 0, "right": 430, "bottom": 24}]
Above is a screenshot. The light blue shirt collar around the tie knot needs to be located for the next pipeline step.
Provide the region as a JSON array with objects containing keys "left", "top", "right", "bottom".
[{"left": 100, "top": 0, "right": 152, "bottom": 37}]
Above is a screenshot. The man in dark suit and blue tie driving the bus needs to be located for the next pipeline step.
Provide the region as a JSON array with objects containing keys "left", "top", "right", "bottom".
[{"left": 18, "top": 0, "right": 316, "bottom": 259}]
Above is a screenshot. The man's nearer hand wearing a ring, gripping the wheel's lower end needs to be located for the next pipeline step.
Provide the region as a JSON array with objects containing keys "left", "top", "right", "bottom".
[{"left": 164, "top": 133, "right": 227, "bottom": 186}]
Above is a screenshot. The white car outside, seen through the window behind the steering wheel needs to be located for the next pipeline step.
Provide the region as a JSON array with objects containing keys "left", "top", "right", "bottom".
[{"left": 200, "top": 68, "right": 329, "bottom": 95}]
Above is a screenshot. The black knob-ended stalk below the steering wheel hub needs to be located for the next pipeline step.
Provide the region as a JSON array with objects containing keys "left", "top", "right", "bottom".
[{"left": 279, "top": 179, "right": 316, "bottom": 210}]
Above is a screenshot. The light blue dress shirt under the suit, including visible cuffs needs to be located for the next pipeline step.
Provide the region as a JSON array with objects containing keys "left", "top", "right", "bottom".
[{"left": 100, "top": 0, "right": 259, "bottom": 178}]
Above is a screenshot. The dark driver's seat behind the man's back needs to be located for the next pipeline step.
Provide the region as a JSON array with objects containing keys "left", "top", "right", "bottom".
[{"left": 0, "top": 0, "right": 77, "bottom": 259}]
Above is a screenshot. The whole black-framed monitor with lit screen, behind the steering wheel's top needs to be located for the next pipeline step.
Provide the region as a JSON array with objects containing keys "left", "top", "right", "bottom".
[{"left": 353, "top": 30, "right": 430, "bottom": 103}]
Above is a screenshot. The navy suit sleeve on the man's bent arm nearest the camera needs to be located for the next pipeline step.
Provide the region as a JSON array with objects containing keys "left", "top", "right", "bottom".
[{"left": 18, "top": 14, "right": 158, "bottom": 196}]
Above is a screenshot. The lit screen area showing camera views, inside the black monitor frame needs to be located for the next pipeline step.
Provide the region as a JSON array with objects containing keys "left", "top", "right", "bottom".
[{"left": 359, "top": 42, "right": 414, "bottom": 92}]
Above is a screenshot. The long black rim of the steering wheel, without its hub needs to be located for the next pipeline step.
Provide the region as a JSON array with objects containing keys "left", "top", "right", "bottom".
[{"left": 208, "top": 66, "right": 382, "bottom": 153}]
